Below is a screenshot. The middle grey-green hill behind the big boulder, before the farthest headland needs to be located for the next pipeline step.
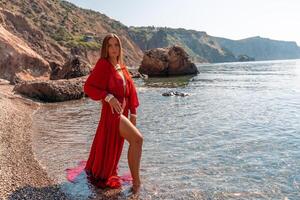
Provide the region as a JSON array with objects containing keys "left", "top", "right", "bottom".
[{"left": 129, "top": 26, "right": 236, "bottom": 62}]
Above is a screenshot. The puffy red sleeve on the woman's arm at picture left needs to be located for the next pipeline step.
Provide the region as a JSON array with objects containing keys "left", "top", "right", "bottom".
[{"left": 83, "top": 59, "right": 109, "bottom": 101}]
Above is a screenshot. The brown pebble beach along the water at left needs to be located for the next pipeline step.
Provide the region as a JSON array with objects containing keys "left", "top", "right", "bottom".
[{"left": 0, "top": 82, "right": 67, "bottom": 199}]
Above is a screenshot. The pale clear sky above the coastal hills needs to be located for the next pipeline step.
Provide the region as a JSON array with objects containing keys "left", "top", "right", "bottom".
[{"left": 68, "top": 0, "right": 300, "bottom": 46}]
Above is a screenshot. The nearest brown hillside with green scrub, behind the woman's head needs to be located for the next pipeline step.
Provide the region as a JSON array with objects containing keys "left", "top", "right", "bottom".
[{"left": 0, "top": 0, "right": 142, "bottom": 65}]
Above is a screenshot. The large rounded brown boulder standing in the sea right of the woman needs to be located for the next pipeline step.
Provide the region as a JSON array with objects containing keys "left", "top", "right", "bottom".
[{"left": 138, "top": 46, "right": 199, "bottom": 76}]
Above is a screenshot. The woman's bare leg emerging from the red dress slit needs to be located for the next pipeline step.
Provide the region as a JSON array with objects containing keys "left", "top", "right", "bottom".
[{"left": 120, "top": 115, "right": 143, "bottom": 192}]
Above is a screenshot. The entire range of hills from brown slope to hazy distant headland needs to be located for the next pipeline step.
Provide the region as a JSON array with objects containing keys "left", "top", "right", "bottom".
[{"left": 0, "top": 0, "right": 300, "bottom": 79}]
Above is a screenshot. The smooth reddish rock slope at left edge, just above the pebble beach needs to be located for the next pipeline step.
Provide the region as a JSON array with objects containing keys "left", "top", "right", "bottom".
[{"left": 0, "top": 25, "right": 51, "bottom": 84}]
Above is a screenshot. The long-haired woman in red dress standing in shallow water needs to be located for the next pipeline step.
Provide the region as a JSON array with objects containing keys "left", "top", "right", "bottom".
[{"left": 84, "top": 34, "right": 143, "bottom": 193}]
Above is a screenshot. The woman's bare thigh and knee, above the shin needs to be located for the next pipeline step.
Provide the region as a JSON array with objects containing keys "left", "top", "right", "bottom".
[{"left": 119, "top": 114, "right": 143, "bottom": 143}]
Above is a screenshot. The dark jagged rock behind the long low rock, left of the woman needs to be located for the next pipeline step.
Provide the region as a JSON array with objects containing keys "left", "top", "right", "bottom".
[{"left": 50, "top": 56, "right": 91, "bottom": 80}]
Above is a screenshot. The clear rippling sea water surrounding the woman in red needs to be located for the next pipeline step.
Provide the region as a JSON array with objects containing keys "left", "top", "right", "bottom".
[{"left": 33, "top": 60, "right": 300, "bottom": 199}]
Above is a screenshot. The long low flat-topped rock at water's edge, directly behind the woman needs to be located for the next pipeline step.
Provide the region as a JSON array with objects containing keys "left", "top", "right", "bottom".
[{"left": 14, "top": 76, "right": 87, "bottom": 102}]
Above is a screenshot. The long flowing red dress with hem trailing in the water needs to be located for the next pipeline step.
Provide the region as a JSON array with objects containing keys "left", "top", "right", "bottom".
[{"left": 66, "top": 58, "right": 139, "bottom": 188}]
